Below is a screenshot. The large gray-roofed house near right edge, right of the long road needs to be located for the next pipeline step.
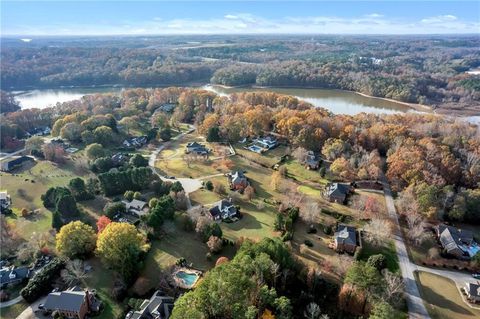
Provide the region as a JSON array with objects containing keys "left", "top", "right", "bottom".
[{"left": 436, "top": 224, "right": 480, "bottom": 260}]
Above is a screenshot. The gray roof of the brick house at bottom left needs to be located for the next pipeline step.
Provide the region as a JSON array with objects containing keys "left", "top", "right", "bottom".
[{"left": 44, "top": 286, "right": 86, "bottom": 312}]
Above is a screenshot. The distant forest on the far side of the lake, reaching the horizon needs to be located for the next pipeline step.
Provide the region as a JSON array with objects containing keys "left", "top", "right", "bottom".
[{"left": 1, "top": 36, "right": 480, "bottom": 114}]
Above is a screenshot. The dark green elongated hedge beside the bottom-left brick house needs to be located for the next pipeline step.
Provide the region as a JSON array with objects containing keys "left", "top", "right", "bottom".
[{"left": 20, "top": 258, "right": 65, "bottom": 303}]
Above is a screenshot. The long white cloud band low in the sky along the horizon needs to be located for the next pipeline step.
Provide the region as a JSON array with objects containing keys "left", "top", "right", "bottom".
[{"left": 3, "top": 13, "right": 480, "bottom": 35}]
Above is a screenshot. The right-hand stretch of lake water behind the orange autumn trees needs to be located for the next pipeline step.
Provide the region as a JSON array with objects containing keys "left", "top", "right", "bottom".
[{"left": 204, "top": 85, "right": 414, "bottom": 115}]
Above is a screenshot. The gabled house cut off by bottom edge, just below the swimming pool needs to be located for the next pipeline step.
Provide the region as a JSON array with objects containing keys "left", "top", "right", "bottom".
[{"left": 125, "top": 290, "right": 174, "bottom": 319}]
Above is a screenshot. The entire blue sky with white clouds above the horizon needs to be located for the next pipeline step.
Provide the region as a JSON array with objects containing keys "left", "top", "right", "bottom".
[{"left": 0, "top": 0, "right": 480, "bottom": 36}]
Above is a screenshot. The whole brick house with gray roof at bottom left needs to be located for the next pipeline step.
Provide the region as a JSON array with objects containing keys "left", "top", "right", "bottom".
[{"left": 39, "top": 286, "right": 100, "bottom": 319}]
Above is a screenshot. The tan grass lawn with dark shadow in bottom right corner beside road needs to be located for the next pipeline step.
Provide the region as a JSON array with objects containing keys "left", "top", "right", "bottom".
[{"left": 415, "top": 272, "right": 480, "bottom": 319}]
